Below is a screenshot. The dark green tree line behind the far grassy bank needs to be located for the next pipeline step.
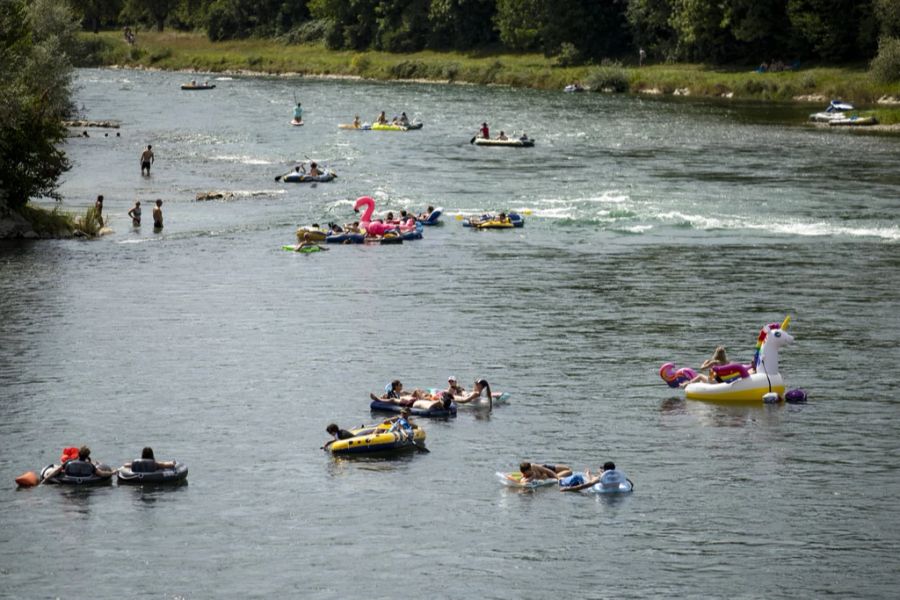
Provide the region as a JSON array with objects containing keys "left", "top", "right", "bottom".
[{"left": 71, "top": 0, "right": 900, "bottom": 68}]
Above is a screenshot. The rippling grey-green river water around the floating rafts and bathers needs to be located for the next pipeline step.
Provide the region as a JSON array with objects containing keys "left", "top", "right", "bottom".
[{"left": 0, "top": 70, "right": 900, "bottom": 598}]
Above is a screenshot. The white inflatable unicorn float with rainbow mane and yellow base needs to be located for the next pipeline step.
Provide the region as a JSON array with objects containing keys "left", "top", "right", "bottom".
[{"left": 659, "top": 316, "right": 794, "bottom": 402}]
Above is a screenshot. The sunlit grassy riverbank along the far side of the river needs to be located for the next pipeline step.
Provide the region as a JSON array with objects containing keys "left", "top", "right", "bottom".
[{"left": 84, "top": 32, "right": 900, "bottom": 115}]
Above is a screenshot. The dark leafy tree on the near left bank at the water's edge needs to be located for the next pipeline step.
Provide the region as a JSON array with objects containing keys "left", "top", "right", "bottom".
[{"left": 0, "top": 0, "right": 77, "bottom": 209}]
